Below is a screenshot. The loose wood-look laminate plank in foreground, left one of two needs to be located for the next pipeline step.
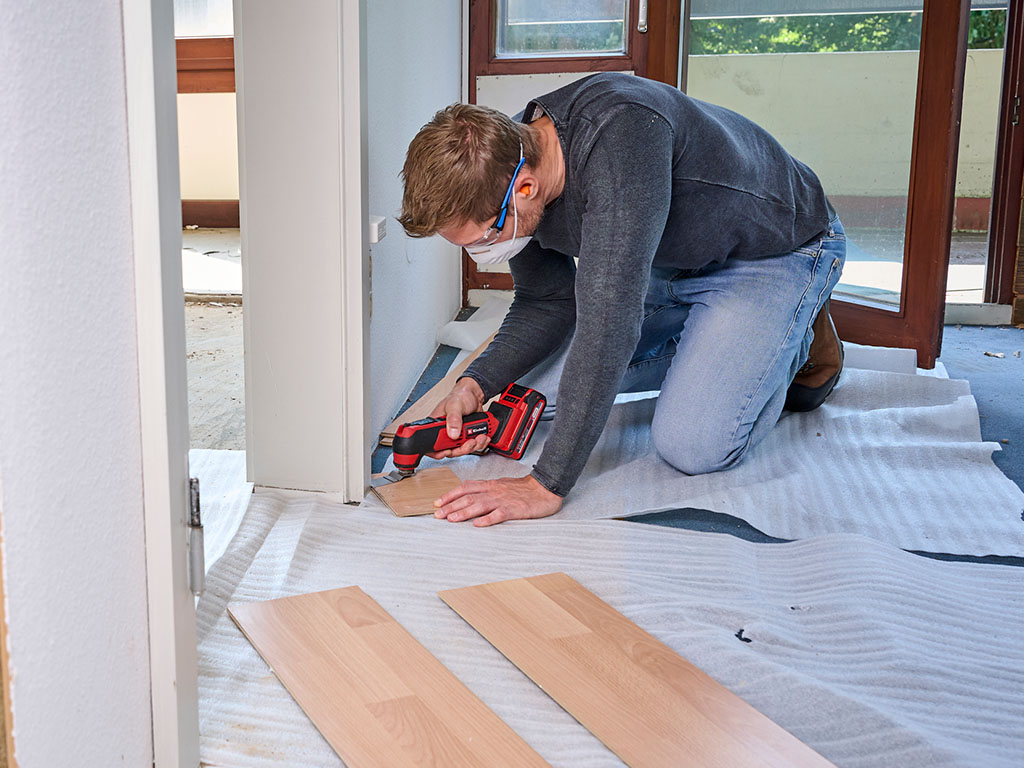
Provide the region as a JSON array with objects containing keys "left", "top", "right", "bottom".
[{"left": 227, "top": 587, "right": 548, "bottom": 768}]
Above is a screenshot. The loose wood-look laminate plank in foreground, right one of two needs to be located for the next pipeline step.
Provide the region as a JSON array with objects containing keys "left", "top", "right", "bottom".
[{"left": 438, "top": 573, "right": 831, "bottom": 768}]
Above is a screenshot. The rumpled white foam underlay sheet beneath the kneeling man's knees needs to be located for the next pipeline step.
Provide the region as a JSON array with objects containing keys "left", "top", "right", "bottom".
[{"left": 386, "top": 345, "right": 1024, "bottom": 557}]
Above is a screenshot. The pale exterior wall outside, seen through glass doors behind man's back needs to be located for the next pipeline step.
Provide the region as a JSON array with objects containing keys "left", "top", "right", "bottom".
[{"left": 687, "top": 50, "right": 1002, "bottom": 198}]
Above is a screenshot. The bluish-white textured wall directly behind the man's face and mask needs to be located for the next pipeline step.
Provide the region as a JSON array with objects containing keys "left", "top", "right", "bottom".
[{"left": 367, "top": 0, "right": 462, "bottom": 430}]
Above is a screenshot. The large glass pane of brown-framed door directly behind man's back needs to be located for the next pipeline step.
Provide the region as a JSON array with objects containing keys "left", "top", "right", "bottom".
[{"left": 687, "top": 0, "right": 922, "bottom": 309}]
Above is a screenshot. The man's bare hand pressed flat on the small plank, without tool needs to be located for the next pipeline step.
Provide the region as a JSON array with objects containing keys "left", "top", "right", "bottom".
[{"left": 434, "top": 475, "right": 562, "bottom": 526}]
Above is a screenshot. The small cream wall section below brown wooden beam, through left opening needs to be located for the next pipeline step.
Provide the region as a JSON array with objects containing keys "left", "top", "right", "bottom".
[{"left": 178, "top": 93, "right": 239, "bottom": 200}]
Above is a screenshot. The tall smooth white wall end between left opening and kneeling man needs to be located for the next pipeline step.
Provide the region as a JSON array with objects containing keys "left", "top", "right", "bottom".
[{"left": 234, "top": 0, "right": 370, "bottom": 499}]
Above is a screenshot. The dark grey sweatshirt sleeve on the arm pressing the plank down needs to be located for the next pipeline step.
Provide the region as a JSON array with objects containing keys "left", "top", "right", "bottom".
[{"left": 523, "top": 105, "right": 673, "bottom": 496}]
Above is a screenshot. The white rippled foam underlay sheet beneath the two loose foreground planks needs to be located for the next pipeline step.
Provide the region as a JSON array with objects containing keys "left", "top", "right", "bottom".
[{"left": 198, "top": 489, "right": 1024, "bottom": 768}]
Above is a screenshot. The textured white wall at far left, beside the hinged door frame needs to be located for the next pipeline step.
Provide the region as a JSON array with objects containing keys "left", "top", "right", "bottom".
[{"left": 0, "top": 0, "right": 153, "bottom": 768}]
